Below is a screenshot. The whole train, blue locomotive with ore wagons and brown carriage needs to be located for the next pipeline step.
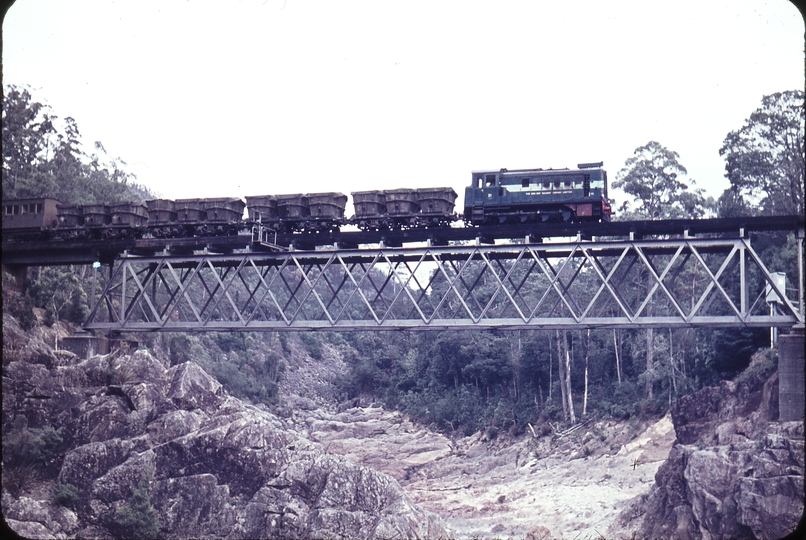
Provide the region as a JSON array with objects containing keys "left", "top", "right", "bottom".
[{"left": 2, "top": 162, "right": 613, "bottom": 242}]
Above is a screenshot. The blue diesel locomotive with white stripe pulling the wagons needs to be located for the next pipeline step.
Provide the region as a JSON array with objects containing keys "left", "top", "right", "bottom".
[{"left": 464, "top": 162, "right": 613, "bottom": 225}]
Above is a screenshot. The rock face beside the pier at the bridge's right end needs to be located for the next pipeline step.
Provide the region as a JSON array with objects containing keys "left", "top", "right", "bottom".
[{"left": 609, "top": 355, "right": 804, "bottom": 540}]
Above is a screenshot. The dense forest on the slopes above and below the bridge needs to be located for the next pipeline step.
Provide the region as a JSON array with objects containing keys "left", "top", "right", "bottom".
[{"left": 2, "top": 86, "right": 804, "bottom": 437}]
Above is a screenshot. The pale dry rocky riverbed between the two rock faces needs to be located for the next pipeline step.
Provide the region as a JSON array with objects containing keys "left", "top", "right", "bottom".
[{"left": 296, "top": 407, "right": 675, "bottom": 538}]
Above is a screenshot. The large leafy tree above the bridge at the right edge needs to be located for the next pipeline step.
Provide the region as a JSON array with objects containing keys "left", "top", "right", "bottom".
[{"left": 719, "top": 90, "right": 804, "bottom": 215}]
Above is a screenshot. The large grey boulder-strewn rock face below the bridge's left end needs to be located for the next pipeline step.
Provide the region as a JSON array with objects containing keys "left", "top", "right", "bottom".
[{"left": 2, "top": 317, "right": 446, "bottom": 538}]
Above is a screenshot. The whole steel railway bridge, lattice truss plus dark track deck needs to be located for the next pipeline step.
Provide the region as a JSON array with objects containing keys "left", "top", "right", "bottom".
[{"left": 2, "top": 216, "right": 804, "bottom": 333}]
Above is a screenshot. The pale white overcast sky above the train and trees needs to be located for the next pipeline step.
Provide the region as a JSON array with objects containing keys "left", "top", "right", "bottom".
[{"left": 2, "top": 0, "right": 804, "bottom": 210}]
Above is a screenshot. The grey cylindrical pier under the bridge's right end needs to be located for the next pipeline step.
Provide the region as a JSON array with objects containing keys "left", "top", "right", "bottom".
[{"left": 778, "top": 323, "right": 804, "bottom": 422}]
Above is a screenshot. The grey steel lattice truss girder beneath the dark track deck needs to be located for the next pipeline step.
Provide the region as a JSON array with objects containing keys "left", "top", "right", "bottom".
[{"left": 84, "top": 238, "right": 803, "bottom": 332}]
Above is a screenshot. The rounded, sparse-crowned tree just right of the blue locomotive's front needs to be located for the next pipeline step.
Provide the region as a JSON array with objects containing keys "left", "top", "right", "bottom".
[{"left": 613, "top": 141, "right": 714, "bottom": 219}]
